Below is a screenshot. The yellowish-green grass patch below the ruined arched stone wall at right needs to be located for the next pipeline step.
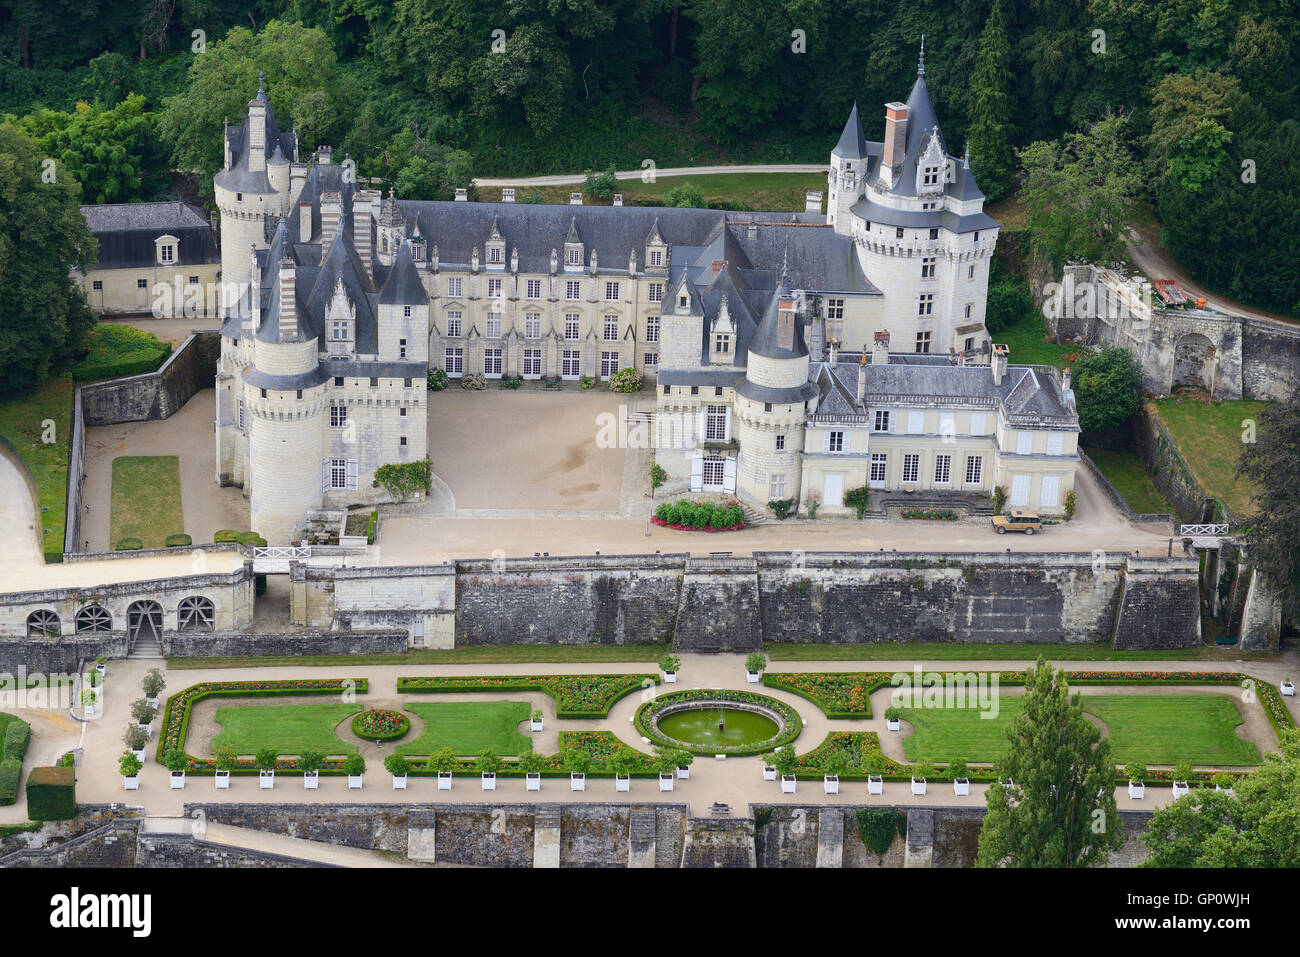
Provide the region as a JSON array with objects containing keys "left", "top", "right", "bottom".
[{"left": 1153, "top": 398, "right": 1269, "bottom": 519}]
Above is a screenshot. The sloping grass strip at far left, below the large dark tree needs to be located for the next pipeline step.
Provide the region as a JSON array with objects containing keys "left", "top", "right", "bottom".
[{"left": 0, "top": 378, "right": 74, "bottom": 562}]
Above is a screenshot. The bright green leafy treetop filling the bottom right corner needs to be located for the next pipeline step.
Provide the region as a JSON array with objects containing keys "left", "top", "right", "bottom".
[{"left": 1143, "top": 728, "right": 1300, "bottom": 867}]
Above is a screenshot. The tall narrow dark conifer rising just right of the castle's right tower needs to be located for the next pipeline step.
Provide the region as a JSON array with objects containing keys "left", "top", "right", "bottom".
[{"left": 969, "top": 0, "right": 1013, "bottom": 200}]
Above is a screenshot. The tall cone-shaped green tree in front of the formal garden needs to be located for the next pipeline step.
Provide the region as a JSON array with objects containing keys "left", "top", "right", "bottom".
[{"left": 976, "top": 658, "right": 1123, "bottom": 867}]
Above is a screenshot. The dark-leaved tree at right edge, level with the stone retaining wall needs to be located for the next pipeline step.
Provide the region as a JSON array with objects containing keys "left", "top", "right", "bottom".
[{"left": 1236, "top": 393, "right": 1300, "bottom": 618}]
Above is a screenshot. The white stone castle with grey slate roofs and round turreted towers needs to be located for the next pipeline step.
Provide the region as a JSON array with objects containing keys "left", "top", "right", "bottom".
[{"left": 215, "top": 53, "right": 1078, "bottom": 544}]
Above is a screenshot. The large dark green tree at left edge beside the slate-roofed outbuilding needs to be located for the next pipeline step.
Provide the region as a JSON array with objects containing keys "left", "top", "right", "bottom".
[{"left": 0, "top": 122, "right": 95, "bottom": 393}]
